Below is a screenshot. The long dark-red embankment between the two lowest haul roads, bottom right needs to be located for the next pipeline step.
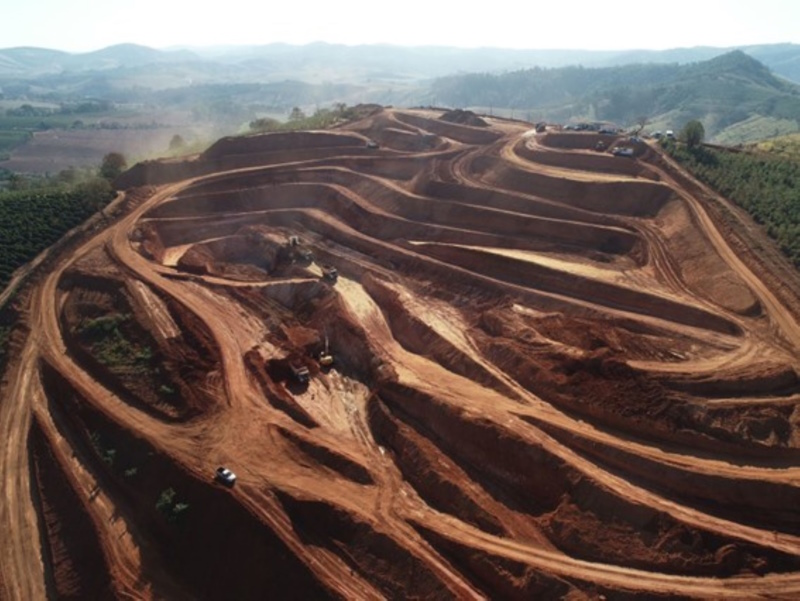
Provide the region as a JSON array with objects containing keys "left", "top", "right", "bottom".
[{"left": 372, "top": 385, "right": 797, "bottom": 574}]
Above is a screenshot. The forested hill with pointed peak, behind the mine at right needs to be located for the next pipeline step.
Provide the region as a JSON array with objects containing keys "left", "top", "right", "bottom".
[{"left": 431, "top": 50, "right": 800, "bottom": 143}]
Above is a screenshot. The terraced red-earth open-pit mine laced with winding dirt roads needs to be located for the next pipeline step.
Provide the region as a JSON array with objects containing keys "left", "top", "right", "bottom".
[{"left": 0, "top": 107, "right": 800, "bottom": 600}]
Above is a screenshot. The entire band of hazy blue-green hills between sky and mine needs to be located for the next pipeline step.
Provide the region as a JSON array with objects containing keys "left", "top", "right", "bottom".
[{"left": 0, "top": 43, "right": 800, "bottom": 154}]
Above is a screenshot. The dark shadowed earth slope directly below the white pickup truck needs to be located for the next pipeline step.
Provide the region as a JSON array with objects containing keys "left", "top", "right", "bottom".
[{"left": 38, "top": 360, "right": 330, "bottom": 599}]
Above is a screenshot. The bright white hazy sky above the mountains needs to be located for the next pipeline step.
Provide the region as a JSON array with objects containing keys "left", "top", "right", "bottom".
[{"left": 6, "top": 0, "right": 800, "bottom": 52}]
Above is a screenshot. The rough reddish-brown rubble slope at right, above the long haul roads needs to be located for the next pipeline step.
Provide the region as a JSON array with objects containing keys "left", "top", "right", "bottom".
[{"left": 474, "top": 330, "right": 791, "bottom": 452}]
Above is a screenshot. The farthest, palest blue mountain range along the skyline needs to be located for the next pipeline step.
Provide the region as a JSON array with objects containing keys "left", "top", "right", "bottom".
[{"left": 0, "top": 42, "right": 800, "bottom": 83}]
